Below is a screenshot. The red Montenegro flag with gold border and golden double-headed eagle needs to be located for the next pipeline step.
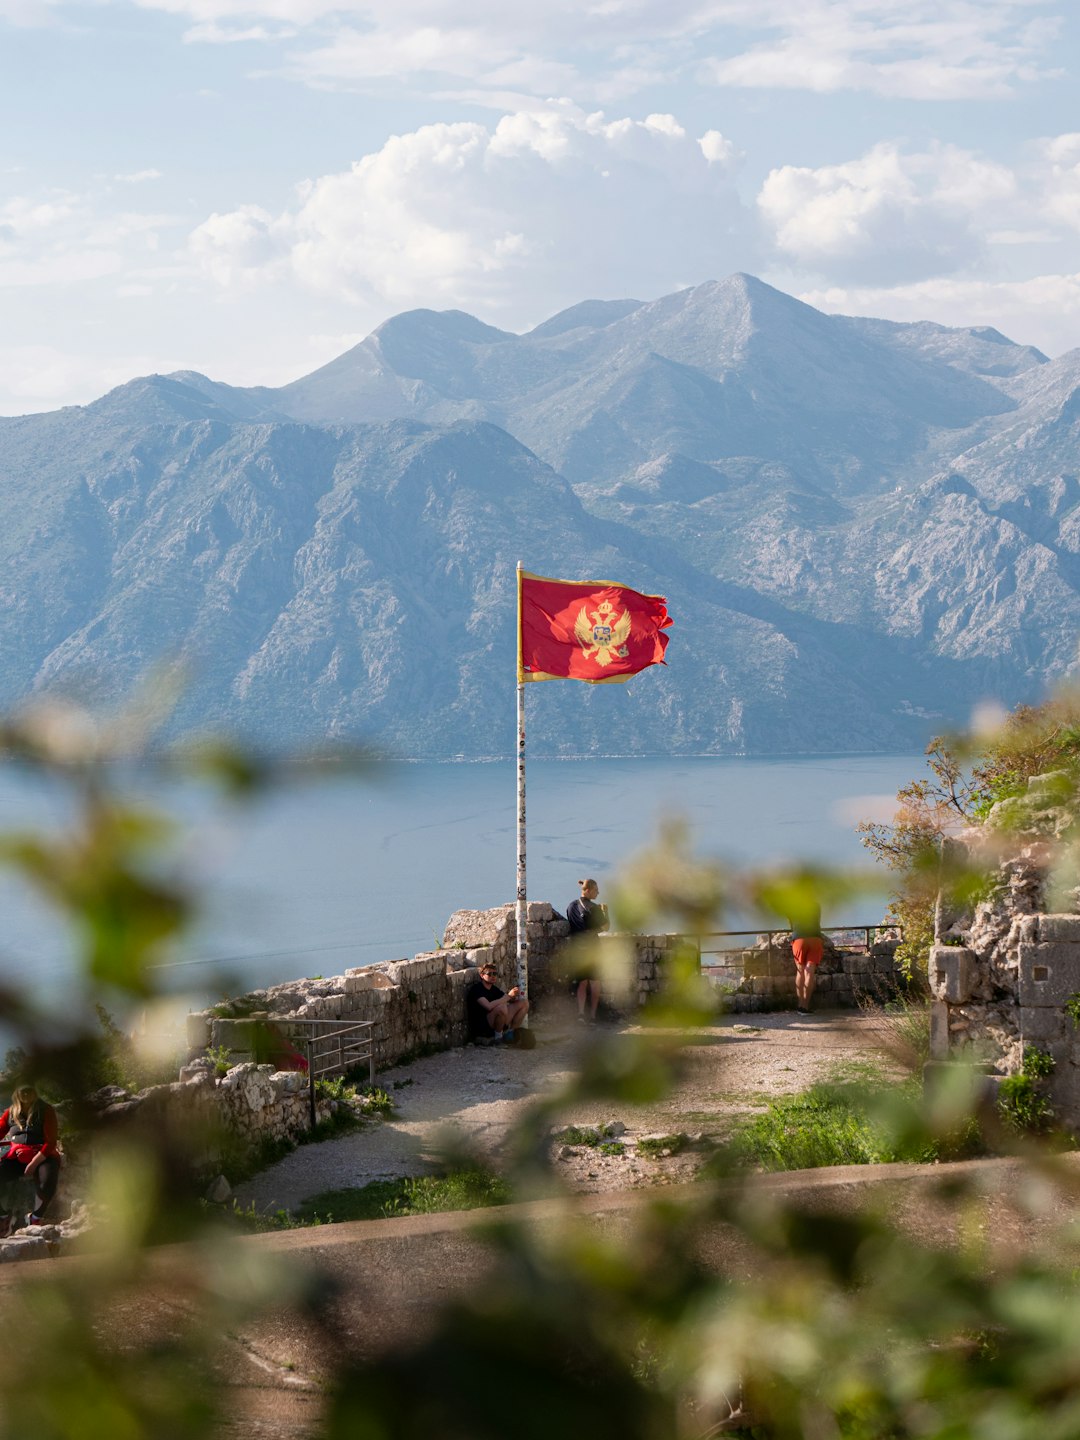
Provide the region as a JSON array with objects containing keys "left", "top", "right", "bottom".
[{"left": 517, "top": 570, "right": 671, "bottom": 685}]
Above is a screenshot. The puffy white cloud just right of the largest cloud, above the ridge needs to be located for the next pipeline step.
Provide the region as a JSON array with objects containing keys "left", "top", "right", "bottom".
[{"left": 757, "top": 144, "right": 1017, "bottom": 282}]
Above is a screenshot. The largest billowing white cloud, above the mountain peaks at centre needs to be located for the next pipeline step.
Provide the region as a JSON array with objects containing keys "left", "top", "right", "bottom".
[{"left": 190, "top": 102, "right": 753, "bottom": 318}]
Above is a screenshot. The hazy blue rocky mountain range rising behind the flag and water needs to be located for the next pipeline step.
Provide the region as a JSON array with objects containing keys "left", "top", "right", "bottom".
[{"left": 0, "top": 275, "right": 1080, "bottom": 757}]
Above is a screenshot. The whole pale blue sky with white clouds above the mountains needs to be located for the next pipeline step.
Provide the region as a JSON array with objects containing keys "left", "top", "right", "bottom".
[{"left": 0, "top": 0, "right": 1080, "bottom": 415}]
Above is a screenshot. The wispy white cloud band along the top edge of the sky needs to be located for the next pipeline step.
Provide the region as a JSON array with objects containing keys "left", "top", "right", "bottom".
[{"left": 116, "top": 0, "right": 1063, "bottom": 102}]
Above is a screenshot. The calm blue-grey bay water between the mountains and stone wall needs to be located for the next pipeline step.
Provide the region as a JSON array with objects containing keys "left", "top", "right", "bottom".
[{"left": 0, "top": 755, "right": 923, "bottom": 994}]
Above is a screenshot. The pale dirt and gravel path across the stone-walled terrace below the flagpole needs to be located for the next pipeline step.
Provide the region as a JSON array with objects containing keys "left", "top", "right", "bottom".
[{"left": 238, "top": 1011, "right": 894, "bottom": 1210}]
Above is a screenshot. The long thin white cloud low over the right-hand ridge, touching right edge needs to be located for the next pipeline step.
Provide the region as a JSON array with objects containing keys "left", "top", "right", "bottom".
[{"left": 799, "top": 274, "right": 1080, "bottom": 356}]
